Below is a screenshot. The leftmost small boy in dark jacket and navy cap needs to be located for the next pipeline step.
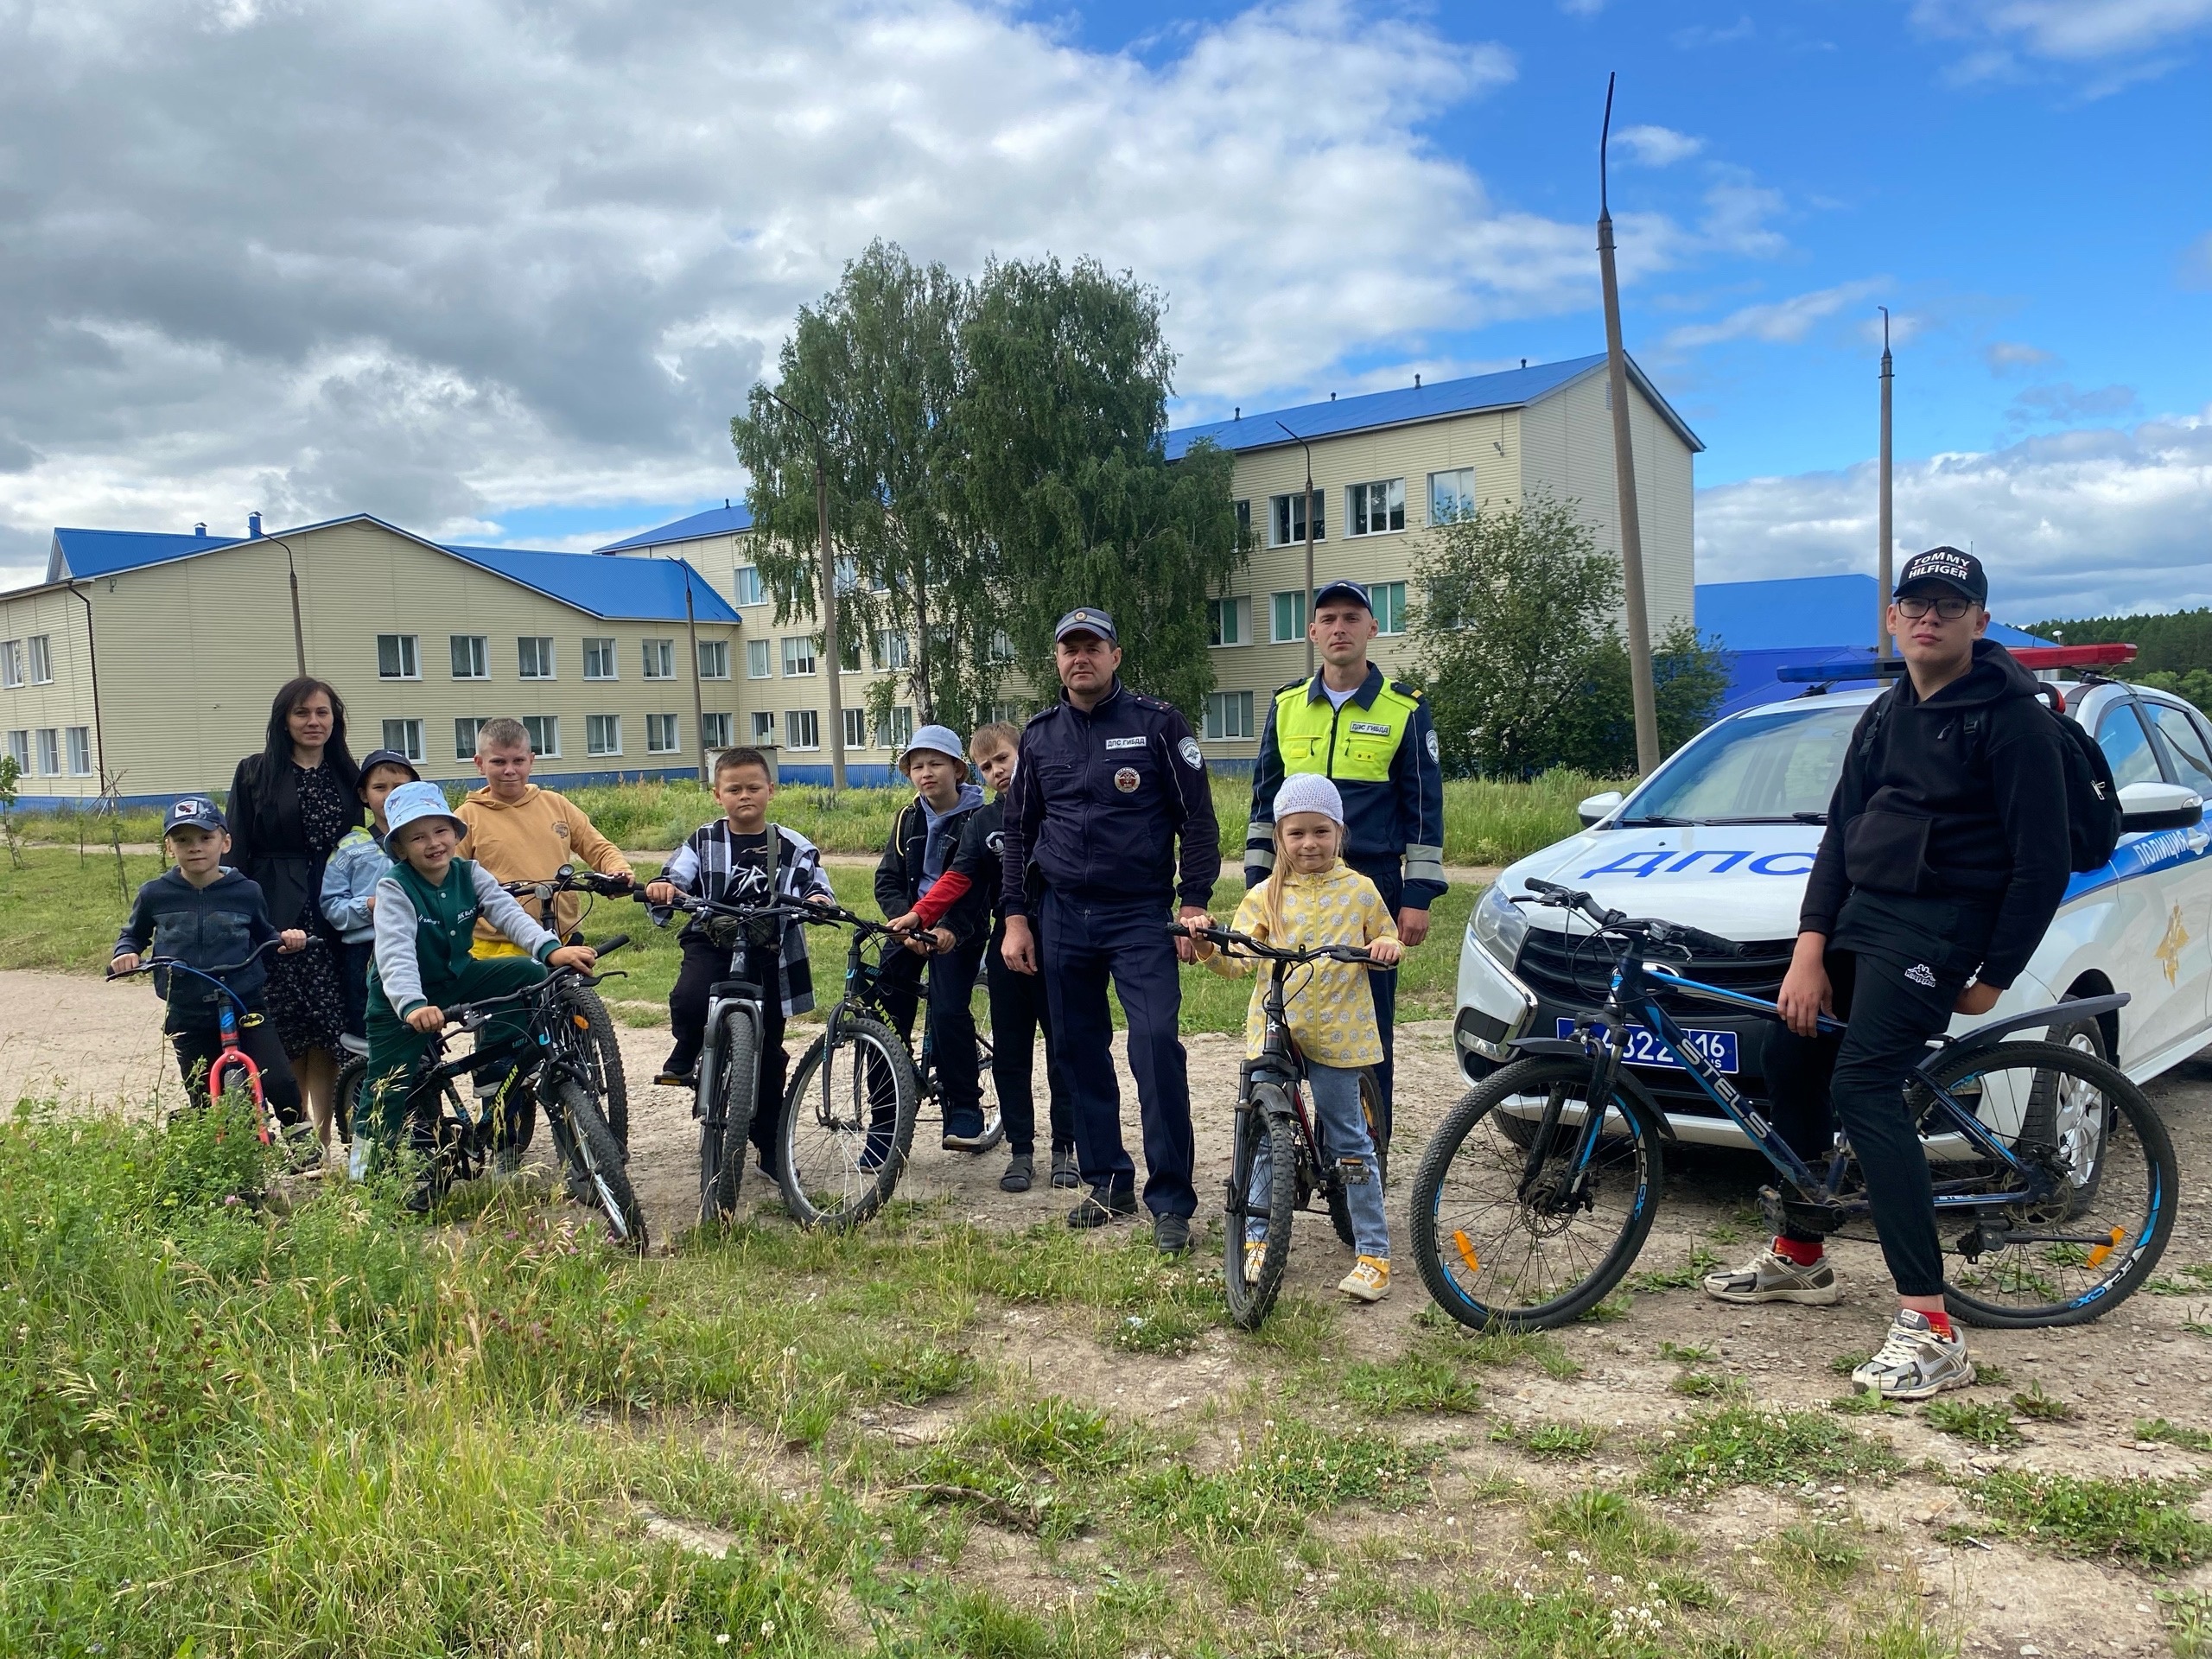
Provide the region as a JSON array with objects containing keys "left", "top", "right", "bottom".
[{"left": 108, "top": 797, "right": 308, "bottom": 1123}]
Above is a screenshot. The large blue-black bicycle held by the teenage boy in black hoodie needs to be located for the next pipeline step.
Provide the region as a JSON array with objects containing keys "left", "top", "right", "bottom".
[{"left": 1411, "top": 880, "right": 2179, "bottom": 1330}]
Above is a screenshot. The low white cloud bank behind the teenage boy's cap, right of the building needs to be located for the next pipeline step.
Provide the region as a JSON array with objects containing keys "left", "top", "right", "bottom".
[{"left": 1697, "top": 407, "right": 2212, "bottom": 621}]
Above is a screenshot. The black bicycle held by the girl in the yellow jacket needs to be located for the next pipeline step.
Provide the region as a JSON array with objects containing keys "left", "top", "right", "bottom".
[{"left": 1168, "top": 923, "right": 1389, "bottom": 1330}]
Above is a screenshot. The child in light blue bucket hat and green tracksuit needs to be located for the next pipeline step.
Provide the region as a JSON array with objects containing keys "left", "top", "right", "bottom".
[{"left": 354, "top": 783, "right": 593, "bottom": 1208}]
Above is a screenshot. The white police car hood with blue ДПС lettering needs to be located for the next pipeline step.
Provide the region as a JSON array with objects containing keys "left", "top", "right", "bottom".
[{"left": 1497, "top": 823, "right": 1821, "bottom": 940}]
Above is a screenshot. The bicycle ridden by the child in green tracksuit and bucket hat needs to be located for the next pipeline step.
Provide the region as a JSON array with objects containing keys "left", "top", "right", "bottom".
[{"left": 349, "top": 933, "right": 648, "bottom": 1252}]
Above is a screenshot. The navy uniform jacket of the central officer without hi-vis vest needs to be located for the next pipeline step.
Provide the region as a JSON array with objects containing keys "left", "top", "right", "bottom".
[{"left": 1000, "top": 679, "right": 1221, "bottom": 916}]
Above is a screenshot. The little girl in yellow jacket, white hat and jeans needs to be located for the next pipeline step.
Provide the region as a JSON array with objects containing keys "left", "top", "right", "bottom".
[{"left": 1199, "top": 772, "right": 1405, "bottom": 1303}]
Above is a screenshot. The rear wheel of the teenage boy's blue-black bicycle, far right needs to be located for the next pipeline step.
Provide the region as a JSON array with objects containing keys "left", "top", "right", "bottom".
[{"left": 1929, "top": 1042, "right": 2181, "bottom": 1330}]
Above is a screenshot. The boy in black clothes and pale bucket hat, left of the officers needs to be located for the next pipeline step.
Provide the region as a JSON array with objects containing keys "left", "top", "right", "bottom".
[{"left": 876, "top": 726, "right": 982, "bottom": 1153}]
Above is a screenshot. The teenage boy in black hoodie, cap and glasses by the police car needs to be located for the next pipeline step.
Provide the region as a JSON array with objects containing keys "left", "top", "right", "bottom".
[{"left": 1706, "top": 546, "right": 2070, "bottom": 1400}]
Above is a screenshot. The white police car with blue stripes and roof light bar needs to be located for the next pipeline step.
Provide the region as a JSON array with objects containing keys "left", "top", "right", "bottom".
[{"left": 1453, "top": 651, "right": 2212, "bottom": 1146}]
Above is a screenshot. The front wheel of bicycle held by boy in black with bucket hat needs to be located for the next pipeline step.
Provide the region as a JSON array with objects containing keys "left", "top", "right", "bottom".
[{"left": 777, "top": 1015, "right": 916, "bottom": 1228}]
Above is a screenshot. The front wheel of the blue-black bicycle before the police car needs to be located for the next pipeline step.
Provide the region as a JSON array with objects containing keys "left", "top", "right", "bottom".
[{"left": 1409, "top": 1055, "right": 1663, "bottom": 1330}]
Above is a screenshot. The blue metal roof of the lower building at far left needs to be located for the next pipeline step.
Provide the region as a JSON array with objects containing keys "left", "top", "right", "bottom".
[{"left": 47, "top": 513, "right": 741, "bottom": 624}]
